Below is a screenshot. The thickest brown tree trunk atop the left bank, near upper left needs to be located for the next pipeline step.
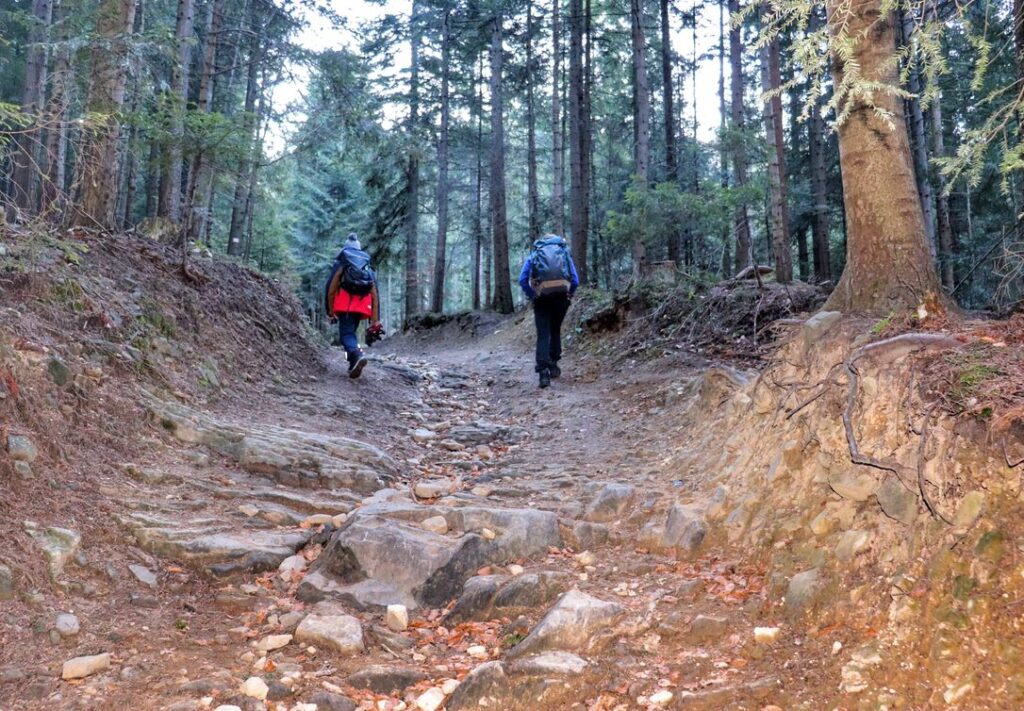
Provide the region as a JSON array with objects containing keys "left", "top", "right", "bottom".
[{"left": 74, "top": 0, "right": 135, "bottom": 229}]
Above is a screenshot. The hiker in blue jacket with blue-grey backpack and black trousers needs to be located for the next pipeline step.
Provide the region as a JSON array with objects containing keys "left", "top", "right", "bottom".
[{"left": 519, "top": 235, "right": 580, "bottom": 387}]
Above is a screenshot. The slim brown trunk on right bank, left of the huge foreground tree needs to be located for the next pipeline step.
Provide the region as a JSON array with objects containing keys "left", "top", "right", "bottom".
[{"left": 761, "top": 38, "right": 793, "bottom": 284}]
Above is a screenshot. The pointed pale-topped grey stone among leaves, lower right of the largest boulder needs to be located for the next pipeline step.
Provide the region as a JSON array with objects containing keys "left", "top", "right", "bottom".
[{"left": 509, "top": 588, "right": 626, "bottom": 658}]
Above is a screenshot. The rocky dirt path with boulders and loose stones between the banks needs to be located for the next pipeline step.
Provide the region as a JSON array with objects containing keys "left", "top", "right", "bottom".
[{"left": 0, "top": 323, "right": 819, "bottom": 711}]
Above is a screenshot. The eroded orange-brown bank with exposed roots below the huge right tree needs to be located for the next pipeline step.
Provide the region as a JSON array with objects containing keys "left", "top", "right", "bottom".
[{"left": 646, "top": 312, "right": 1024, "bottom": 708}]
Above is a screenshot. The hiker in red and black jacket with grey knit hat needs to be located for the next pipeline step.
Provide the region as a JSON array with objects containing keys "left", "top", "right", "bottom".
[{"left": 324, "top": 233, "right": 383, "bottom": 378}]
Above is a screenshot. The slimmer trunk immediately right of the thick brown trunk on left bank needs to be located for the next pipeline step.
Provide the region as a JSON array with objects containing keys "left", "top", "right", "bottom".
[{"left": 159, "top": 0, "right": 194, "bottom": 222}]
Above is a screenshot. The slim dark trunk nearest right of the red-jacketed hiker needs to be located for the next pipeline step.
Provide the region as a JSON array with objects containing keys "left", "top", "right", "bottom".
[{"left": 404, "top": 0, "right": 422, "bottom": 324}]
